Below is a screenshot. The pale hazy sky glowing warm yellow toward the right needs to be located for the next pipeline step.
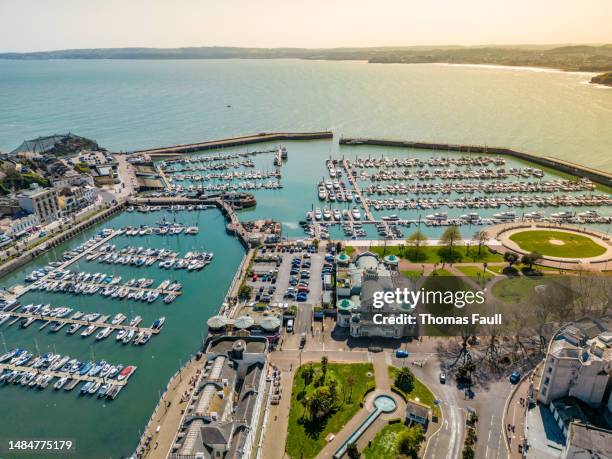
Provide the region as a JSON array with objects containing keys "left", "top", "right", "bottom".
[{"left": 0, "top": 0, "right": 612, "bottom": 51}]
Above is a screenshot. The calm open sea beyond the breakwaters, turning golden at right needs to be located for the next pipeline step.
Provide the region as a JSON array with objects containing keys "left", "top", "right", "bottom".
[{"left": 0, "top": 60, "right": 612, "bottom": 170}]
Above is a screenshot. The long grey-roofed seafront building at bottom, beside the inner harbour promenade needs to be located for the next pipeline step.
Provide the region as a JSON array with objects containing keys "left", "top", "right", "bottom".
[{"left": 169, "top": 336, "right": 267, "bottom": 459}]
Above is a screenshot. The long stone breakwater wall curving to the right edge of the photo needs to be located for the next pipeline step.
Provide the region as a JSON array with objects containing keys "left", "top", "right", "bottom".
[{"left": 340, "top": 138, "right": 612, "bottom": 186}]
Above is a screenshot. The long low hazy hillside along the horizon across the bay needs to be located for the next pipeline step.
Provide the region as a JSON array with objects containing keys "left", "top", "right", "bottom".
[{"left": 0, "top": 45, "right": 612, "bottom": 72}]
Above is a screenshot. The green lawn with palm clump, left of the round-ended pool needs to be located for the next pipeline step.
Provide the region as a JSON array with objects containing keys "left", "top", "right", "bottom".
[{"left": 285, "top": 363, "right": 374, "bottom": 459}]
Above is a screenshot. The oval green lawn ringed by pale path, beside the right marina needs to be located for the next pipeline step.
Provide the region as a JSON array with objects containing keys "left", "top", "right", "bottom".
[{"left": 510, "top": 230, "right": 606, "bottom": 258}]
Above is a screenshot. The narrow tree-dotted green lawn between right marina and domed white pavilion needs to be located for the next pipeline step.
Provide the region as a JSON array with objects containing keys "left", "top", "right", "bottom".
[{"left": 371, "top": 245, "right": 504, "bottom": 263}]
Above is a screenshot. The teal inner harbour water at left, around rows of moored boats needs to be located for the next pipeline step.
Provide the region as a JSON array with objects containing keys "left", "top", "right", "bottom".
[{"left": 0, "top": 206, "right": 244, "bottom": 457}]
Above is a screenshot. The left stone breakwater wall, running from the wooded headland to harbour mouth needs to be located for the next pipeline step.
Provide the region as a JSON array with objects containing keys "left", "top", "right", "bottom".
[{"left": 128, "top": 131, "right": 333, "bottom": 159}]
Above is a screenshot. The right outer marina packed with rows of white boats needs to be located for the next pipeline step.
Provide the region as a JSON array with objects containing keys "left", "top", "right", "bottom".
[{"left": 300, "top": 147, "right": 612, "bottom": 240}]
